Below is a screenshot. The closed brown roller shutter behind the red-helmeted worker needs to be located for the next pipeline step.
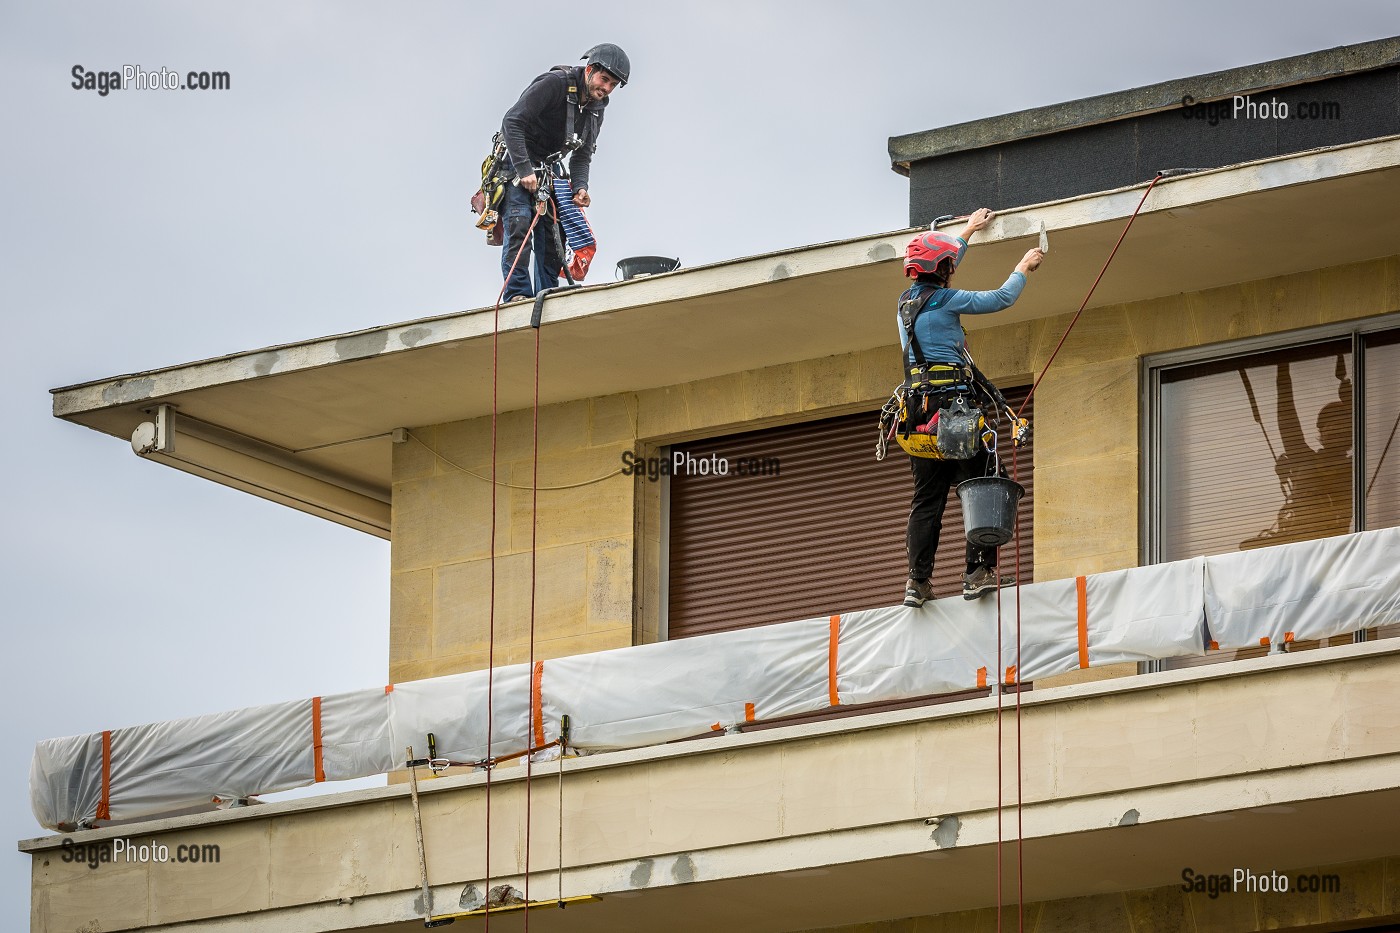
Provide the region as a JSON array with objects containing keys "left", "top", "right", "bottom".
[{"left": 668, "top": 387, "right": 1033, "bottom": 639}]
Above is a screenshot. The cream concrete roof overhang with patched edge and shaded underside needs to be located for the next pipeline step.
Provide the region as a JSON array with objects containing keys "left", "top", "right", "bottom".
[{"left": 53, "top": 137, "right": 1400, "bottom": 537}]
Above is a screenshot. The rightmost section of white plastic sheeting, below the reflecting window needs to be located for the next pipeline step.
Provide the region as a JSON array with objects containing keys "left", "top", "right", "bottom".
[{"left": 1205, "top": 528, "right": 1400, "bottom": 650}]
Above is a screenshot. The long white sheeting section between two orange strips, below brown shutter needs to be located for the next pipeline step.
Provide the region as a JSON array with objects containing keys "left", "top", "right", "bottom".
[{"left": 536, "top": 619, "right": 832, "bottom": 749}]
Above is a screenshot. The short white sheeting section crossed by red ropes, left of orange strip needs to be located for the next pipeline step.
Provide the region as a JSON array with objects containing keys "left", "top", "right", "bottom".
[{"left": 392, "top": 664, "right": 531, "bottom": 773}]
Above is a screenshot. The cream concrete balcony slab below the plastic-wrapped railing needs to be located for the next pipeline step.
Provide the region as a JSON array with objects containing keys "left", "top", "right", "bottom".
[{"left": 20, "top": 640, "right": 1400, "bottom": 933}]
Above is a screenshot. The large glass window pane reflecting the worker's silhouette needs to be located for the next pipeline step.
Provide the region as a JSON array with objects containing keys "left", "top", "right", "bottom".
[{"left": 1159, "top": 339, "right": 1349, "bottom": 560}]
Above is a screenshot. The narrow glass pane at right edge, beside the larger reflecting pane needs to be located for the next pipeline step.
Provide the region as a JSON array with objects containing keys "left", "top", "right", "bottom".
[{"left": 1362, "top": 331, "right": 1400, "bottom": 528}]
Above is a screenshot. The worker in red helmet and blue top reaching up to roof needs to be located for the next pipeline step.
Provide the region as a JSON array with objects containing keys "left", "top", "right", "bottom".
[{"left": 899, "top": 207, "right": 1044, "bottom": 608}]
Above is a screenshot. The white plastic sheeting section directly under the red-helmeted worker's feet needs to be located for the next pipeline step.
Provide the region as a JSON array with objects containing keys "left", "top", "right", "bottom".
[{"left": 836, "top": 598, "right": 997, "bottom": 705}]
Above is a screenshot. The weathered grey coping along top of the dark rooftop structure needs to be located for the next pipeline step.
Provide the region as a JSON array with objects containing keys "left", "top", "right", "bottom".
[{"left": 889, "top": 36, "right": 1400, "bottom": 175}]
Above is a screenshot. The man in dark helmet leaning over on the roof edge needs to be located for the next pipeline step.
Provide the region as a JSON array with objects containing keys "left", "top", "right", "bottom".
[{"left": 500, "top": 42, "right": 631, "bottom": 301}]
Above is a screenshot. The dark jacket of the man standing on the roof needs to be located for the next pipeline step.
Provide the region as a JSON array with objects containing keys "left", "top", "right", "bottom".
[{"left": 501, "top": 64, "right": 608, "bottom": 191}]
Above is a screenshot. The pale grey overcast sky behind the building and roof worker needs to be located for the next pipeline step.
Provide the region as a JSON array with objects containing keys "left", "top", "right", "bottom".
[{"left": 0, "top": 0, "right": 1400, "bottom": 929}]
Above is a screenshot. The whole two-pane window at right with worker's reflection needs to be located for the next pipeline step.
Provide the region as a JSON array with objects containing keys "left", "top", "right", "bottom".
[{"left": 1144, "top": 318, "right": 1400, "bottom": 661}]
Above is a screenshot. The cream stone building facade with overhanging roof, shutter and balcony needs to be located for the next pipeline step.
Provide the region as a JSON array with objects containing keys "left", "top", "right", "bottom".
[{"left": 21, "top": 39, "right": 1400, "bottom": 933}]
